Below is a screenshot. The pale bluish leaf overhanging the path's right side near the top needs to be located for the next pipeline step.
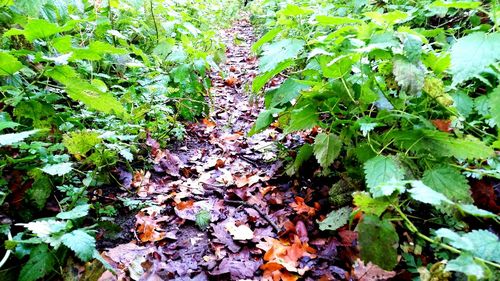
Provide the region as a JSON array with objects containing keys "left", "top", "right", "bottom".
[{"left": 259, "top": 39, "right": 305, "bottom": 72}]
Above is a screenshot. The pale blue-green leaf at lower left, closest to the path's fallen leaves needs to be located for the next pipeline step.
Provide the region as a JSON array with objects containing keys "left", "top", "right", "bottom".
[{"left": 61, "top": 229, "right": 95, "bottom": 261}]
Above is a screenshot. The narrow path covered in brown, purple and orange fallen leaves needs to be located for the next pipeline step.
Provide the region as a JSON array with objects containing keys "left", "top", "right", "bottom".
[{"left": 94, "top": 14, "right": 376, "bottom": 280}]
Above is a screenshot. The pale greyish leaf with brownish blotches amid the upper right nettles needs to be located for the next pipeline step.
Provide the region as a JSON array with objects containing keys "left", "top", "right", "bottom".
[{"left": 392, "top": 56, "right": 425, "bottom": 94}]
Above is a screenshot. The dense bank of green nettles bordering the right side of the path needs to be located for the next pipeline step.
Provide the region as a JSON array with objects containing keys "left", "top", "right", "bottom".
[{"left": 250, "top": 1, "right": 500, "bottom": 279}]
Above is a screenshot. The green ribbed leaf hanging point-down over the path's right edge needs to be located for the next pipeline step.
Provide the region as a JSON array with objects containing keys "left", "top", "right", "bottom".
[{"left": 314, "top": 133, "right": 342, "bottom": 169}]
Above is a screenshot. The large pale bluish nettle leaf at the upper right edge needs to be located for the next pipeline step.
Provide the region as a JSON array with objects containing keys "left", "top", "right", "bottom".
[{"left": 450, "top": 32, "right": 500, "bottom": 85}]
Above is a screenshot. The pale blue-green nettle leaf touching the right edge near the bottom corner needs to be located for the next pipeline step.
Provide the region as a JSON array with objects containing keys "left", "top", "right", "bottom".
[{"left": 436, "top": 228, "right": 500, "bottom": 263}]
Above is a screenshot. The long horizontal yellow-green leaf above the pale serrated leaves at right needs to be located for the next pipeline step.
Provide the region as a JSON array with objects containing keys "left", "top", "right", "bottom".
[{"left": 392, "top": 130, "right": 495, "bottom": 159}]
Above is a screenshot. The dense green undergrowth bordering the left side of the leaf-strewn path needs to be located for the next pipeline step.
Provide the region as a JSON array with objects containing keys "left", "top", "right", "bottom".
[{"left": 0, "top": 0, "right": 238, "bottom": 280}]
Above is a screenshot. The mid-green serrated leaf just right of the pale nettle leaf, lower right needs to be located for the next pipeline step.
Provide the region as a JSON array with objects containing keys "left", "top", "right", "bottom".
[{"left": 422, "top": 166, "right": 472, "bottom": 203}]
